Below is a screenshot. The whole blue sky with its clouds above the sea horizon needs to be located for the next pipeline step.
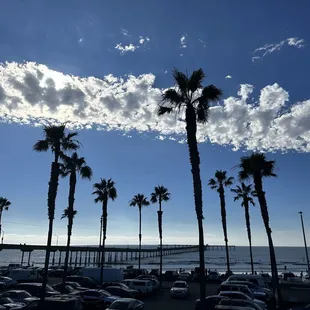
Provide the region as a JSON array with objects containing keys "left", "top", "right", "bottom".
[{"left": 0, "top": 0, "right": 310, "bottom": 245}]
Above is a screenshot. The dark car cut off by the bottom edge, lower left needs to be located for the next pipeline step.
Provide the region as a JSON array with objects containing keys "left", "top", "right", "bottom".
[{"left": 12, "top": 295, "right": 83, "bottom": 310}]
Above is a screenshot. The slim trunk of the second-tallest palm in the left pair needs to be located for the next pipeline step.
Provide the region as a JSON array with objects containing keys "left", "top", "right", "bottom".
[{"left": 63, "top": 171, "right": 76, "bottom": 283}]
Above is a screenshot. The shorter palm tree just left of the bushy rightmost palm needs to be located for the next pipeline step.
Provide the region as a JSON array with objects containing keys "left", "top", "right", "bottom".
[{"left": 231, "top": 182, "right": 256, "bottom": 274}]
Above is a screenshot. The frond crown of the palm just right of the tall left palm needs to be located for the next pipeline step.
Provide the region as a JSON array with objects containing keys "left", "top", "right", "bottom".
[{"left": 60, "top": 152, "right": 93, "bottom": 180}]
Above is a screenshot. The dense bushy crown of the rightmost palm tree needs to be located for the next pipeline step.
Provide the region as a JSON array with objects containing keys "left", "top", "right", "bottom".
[{"left": 239, "top": 153, "right": 277, "bottom": 180}]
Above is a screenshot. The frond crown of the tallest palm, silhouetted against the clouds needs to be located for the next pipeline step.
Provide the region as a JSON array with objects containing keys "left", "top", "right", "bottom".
[{"left": 158, "top": 69, "right": 222, "bottom": 123}]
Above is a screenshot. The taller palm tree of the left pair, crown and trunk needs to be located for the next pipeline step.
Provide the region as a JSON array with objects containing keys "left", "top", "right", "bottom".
[{"left": 33, "top": 125, "right": 79, "bottom": 301}]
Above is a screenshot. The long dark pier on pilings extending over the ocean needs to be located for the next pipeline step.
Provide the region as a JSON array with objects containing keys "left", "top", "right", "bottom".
[{"left": 0, "top": 244, "right": 235, "bottom": 267}]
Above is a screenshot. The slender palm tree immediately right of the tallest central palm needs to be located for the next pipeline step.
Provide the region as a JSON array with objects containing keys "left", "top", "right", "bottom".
[{"left": 208, "top": 170, "right": 234, "bottom": 274}]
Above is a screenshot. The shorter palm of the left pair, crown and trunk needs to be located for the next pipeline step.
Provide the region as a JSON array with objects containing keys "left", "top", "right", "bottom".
[{"left": 60, "top": 152, "right": 93, "bottom": 283}]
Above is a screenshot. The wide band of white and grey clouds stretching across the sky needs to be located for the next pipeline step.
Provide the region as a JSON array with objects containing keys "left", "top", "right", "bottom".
[{"left": 0, "top": 62, "right": 310, "bottom": 152}]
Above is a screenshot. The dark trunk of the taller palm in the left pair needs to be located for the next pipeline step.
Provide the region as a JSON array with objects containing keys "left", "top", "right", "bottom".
[{"left": 41, "top": 161, "right": 59, "bottom": 301}]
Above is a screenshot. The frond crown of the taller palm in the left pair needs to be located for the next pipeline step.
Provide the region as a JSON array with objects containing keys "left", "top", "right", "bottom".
[{"left": 33, "top": 125, "right": 80, "bottom": 155}]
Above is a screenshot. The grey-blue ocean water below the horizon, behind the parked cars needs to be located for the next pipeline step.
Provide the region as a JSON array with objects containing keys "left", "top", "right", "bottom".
[{"left": 0, "top": 245, "right": 307, "bottom": 274}]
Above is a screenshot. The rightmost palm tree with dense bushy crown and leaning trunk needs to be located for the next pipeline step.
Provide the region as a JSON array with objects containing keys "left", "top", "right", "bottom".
[{"left": 239, "top": 153, "right": 282, "bottom": 304}]
